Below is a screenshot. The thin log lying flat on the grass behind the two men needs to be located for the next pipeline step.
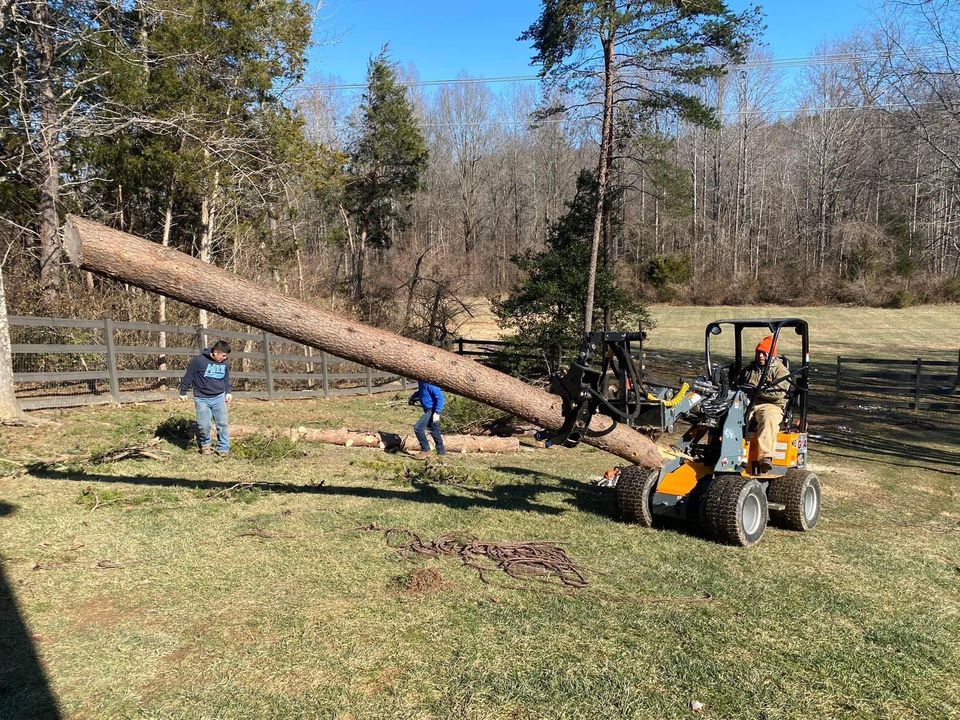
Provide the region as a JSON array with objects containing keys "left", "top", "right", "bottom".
[{"left": 230, "top": 425, "right": 520, "bottom": 454}]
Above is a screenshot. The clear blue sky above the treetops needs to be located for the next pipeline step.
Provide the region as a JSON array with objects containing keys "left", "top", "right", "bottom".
[{"left": 307, "top": 0, "right": 874, "bottom": 83}]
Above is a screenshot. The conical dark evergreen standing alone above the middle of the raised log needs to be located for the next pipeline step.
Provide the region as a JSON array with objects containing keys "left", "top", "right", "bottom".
[{"left": 343, "top": 49, "right": 427, "bottom": 303}]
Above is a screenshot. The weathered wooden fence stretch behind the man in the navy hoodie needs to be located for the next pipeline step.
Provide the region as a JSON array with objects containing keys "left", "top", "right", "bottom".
[{"left": 10, "top": 316, "right": 408, "bottom": 409}]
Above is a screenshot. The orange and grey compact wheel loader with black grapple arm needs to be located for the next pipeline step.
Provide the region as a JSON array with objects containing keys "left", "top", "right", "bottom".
[{"left": 539, "top": 318, "right": 820, "bottom": 546}]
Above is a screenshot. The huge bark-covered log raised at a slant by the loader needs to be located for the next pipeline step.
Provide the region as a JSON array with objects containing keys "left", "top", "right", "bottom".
[{"left": 64, "top": 216, "right": 661, "bottom": 468}]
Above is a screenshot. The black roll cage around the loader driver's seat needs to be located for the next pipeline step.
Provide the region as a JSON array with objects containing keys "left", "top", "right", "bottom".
[{"left": 704, "top": 318, "right": 810, "bottom": 432}]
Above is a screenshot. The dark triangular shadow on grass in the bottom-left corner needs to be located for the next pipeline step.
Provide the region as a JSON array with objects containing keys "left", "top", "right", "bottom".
[{"left": 0, "top": 502, "right": 62, "bottom": 720}]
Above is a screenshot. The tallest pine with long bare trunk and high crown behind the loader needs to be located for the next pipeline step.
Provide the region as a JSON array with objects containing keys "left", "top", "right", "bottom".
[{"left": 520, "top": 0, "right": 758, "bottom": 331}]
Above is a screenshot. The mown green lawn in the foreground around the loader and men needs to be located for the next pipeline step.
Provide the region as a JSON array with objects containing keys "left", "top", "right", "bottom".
[{"left": 0, "top": 394, "right": 960, "bottom": 720}]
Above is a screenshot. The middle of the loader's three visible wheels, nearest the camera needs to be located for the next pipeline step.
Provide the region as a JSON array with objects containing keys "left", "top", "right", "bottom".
[{"left": 703, "top": 475, "right": 767, "bottom": 547}]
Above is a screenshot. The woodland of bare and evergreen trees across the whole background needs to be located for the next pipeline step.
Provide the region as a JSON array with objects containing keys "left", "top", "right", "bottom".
[{"left": 0, "top": 0, "right": 960, "bottom": 348}]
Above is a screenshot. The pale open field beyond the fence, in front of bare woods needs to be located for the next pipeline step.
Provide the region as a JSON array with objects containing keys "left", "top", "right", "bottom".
[{"left": 460, "top": 305, "right": 960, "bottom": 361}]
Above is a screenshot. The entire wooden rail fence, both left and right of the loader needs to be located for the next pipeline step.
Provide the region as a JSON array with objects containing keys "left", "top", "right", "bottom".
[{"left": 10, "top": 316, "right": 960, "bottom": 412}]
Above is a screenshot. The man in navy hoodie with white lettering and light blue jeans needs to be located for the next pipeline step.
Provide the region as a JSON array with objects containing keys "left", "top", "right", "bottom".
[{"left": 180, "top": 340, "right": 233, "bottom": 457}]
